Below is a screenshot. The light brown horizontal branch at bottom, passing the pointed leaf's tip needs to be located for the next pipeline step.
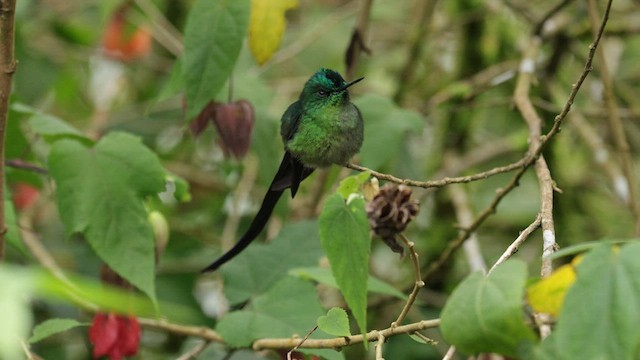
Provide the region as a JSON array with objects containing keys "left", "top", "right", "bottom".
[{"left": 253, "top": 319, "right": 440, "bottom": 351}]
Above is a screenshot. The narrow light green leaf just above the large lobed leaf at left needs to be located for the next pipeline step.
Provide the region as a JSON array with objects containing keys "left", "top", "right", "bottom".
[{"left": 11, "top": 103, "right": 92, "bottom": 144}]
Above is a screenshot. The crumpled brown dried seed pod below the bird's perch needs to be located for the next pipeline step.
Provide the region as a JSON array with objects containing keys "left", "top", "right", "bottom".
[{"left": 366, "top": 184, "right": 420, "bottom": 254}]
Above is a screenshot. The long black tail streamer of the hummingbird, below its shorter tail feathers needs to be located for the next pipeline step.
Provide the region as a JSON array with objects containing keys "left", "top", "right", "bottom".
[{"left": 202, "top": 190, "right": 284, "bottom": 272}]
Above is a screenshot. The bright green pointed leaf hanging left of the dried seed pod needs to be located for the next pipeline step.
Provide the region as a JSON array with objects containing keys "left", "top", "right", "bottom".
[{"left": 320, "top": 194, "right": 371, "bottom": 342}]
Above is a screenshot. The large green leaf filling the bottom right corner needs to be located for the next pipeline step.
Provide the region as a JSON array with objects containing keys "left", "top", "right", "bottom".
[{"left": 545, "top": 242, "right": 640, "bottom": 360}]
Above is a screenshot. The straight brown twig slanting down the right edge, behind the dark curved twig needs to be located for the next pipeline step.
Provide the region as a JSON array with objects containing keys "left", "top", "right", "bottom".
[{"left": 587, "top": 0, "right": 640, "bottom": 235}]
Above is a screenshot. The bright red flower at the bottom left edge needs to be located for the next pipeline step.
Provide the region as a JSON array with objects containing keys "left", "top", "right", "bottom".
[{"left": 89, "top": 313, "right": 140, "bottom": 360}]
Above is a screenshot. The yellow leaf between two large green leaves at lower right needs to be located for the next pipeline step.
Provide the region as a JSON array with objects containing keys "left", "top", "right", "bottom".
[{"left": 527, "top": 256, "right": 582, "bottom": 316}]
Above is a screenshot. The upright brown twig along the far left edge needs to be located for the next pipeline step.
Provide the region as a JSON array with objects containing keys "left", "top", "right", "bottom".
[{"left": 0, "top": 0, "right": 16, "bottom": 261}]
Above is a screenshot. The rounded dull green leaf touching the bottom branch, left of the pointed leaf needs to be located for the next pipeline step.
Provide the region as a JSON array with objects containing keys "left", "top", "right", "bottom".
[{"left": 216, "top": 276, "right": 324, "bottom": 347}]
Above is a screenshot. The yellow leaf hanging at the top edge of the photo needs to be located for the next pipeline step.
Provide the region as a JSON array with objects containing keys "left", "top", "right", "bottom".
[{"left": 249, "top": 0, "right": 298, "bottom": 65}]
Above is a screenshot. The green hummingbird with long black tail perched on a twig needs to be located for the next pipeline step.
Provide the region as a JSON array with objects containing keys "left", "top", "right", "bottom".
[{"left": 202, "top": 69, "right": 364, "bottom": 272}]
